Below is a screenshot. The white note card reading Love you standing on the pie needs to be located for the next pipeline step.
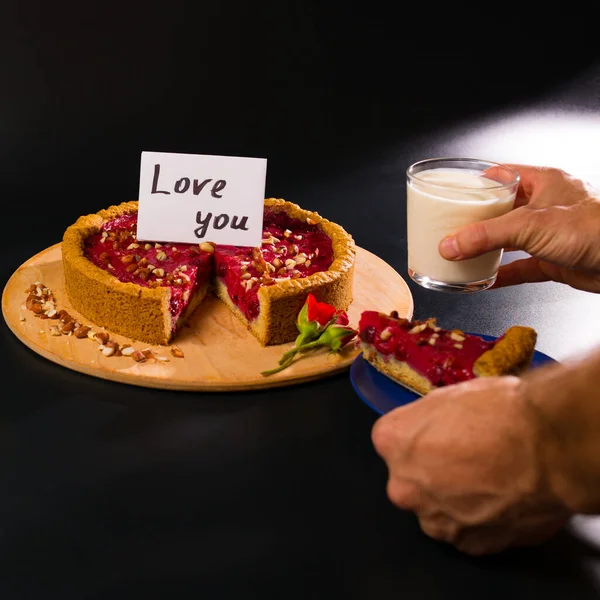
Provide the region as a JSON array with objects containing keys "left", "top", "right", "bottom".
[{"left": 137, "top": 152, "right": 267, "bottom": 246}]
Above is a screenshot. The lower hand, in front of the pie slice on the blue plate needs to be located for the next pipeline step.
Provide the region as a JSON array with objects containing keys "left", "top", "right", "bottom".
[{"left": 372, "top": 377, "right": 570, "bottom": 555}]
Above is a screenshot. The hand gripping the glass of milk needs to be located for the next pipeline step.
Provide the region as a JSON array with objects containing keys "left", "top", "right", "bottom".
[{"left": 439, "top": 165, "right": 600, "bottom": 292}]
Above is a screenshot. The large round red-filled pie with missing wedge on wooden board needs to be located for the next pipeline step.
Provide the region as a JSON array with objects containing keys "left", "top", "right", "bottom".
[{"left": 62, "top": 198, "right": 355, "bottom": 346}]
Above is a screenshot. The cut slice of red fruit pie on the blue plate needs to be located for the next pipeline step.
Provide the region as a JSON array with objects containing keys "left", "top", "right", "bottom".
[{"left": 358, "top": 311, "right": 537, "bottom": 395}]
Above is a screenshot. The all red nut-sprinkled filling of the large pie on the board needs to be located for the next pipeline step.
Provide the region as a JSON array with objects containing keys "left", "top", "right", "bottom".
[{"left": 84, "top": 209, "right": 333, "bottom": 330}]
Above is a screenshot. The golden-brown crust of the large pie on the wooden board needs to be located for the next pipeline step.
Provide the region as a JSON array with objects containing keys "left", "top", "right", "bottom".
[{"left": 62, "top": 198, "right": 355, "bottom": 345}]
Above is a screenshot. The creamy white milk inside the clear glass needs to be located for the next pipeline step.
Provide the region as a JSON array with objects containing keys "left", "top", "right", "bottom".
[{"left": 406, "top": 168, "right": 516, "bottom": 283}]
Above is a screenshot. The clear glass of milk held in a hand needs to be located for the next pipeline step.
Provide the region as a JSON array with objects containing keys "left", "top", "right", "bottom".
[{"left": 406, "top": 158, "right": 519, "bottom": 292}]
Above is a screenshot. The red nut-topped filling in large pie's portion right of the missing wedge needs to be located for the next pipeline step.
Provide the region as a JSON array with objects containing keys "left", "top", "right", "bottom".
[{"left": 215, "top": 209, "right": 333, "bottom": 321}]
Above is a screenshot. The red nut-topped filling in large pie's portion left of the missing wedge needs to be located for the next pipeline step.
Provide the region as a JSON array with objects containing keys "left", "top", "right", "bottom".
[{"left": 85, "top": 214, "right": 212, "bottom": 330}]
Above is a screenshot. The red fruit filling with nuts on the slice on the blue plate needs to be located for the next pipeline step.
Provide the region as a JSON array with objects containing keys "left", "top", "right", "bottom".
[{"left": 359, "top": 311, "right": 496, "bottom": 387}]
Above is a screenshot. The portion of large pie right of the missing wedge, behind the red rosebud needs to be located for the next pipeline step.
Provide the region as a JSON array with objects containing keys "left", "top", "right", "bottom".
[{"left": 215, "top": 199, "right": 355, "bottom": 345}]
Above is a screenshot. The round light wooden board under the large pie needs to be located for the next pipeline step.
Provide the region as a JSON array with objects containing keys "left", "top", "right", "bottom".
[{"left": 2, "top": 244, "right": 413, "bottom": 391}]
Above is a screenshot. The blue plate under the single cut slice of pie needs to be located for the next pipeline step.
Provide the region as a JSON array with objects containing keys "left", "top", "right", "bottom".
[{"left": 350, "top": 333, "right": 556, "bottom": 415}]
